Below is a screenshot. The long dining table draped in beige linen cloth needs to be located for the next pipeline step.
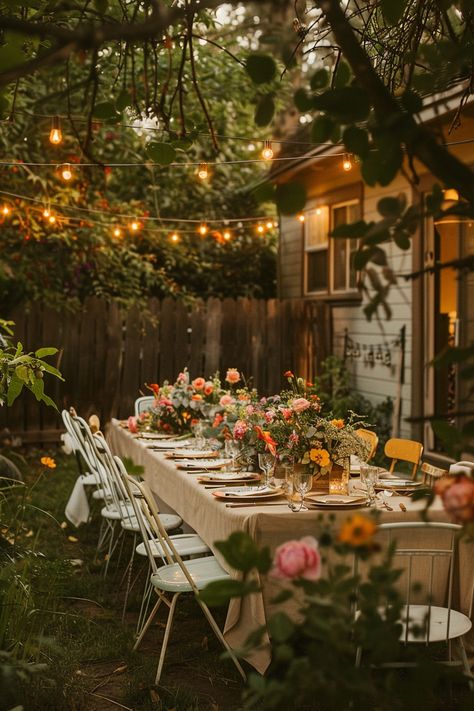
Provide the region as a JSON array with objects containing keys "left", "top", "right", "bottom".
[{"left": 107, "top": 420, "right": 474, "bottom": 673}]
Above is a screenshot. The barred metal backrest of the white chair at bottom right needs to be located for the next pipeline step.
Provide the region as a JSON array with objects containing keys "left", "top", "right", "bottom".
[{"left": 379, "top": 521, "right": 461, "bottom": 644}]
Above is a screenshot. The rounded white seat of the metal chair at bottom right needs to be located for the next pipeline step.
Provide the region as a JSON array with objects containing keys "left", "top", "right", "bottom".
[{"left": 400, "top": 605, "right": 472, "bottom": 644}]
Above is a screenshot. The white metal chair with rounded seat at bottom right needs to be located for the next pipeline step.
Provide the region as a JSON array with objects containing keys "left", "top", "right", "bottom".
[{"left": 357, "top": 521, "right": 474, "bottom": 679}]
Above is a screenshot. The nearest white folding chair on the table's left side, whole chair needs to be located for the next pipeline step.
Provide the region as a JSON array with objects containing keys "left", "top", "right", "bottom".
[{"left": 127, "top": 476, "right": 246, "bottom": 684}]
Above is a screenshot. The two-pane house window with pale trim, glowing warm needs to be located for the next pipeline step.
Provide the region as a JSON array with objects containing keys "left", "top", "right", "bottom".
[{"left": 304, "top": 200, "right": 360, "bottom": 294}]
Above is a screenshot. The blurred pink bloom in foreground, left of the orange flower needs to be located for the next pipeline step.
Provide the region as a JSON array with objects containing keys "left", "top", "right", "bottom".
[{"left": 271, "top": 536, "right": 321, "bottom": 580}]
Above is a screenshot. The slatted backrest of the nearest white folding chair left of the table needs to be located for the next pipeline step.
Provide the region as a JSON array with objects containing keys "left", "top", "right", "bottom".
[{"left": 125, "top": 474, "right": 199, "bottom": 595}]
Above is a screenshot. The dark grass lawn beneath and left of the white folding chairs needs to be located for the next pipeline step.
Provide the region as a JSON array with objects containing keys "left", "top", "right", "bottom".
[{"left": 0, "top": 450, "right": 242, "bottom": 711}]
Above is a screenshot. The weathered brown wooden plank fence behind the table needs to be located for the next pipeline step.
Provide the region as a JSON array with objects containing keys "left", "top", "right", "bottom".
[{"left": 0, "top": 298, "right": 329, "bottom": 442}]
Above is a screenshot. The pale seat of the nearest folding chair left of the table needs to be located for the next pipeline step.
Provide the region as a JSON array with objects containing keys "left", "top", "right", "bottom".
[{"left": 150, "top": 555, "right": 230, "bottom": 592}]
